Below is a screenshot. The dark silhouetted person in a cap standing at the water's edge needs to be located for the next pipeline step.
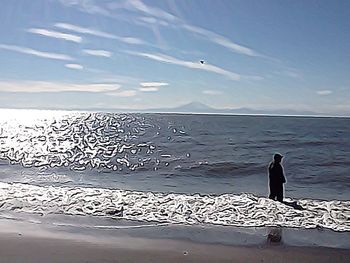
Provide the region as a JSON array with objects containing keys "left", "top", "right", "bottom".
[{"left": 269, "top": 153, "right": 286, "bottom": 202}]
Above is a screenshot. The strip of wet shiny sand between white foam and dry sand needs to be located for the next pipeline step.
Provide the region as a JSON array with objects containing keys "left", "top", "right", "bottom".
[{"left": 0, "top": 211, "right": 350, "bottom": 250}]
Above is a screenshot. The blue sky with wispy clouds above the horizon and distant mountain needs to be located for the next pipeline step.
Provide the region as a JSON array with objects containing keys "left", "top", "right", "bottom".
[{"left": 0, "top": 0, "right": 350, "bottom": 116}]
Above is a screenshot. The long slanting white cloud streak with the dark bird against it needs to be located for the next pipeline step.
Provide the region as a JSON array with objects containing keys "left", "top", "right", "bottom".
[{"left": 125, "top": 51, "right": 240, "bottom": 80}]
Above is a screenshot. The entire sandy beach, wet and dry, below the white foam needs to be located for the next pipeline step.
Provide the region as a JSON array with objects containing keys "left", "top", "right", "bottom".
[{"left": 0, "top": 214, "right": 350, "bottom": 263}]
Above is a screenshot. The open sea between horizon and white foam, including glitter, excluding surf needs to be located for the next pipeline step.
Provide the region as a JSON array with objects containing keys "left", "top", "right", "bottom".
[{"left": 0, "top": 110, "right": 350, "bottom": 200}]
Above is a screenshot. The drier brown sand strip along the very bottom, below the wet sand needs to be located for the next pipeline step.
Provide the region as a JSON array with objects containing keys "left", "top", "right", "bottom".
[{"left": 0, "top": 234, "right": 350, "bottom": 263}]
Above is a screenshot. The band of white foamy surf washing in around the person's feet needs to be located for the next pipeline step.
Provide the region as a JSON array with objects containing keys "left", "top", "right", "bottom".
[{"left": 0, "top": 183, "right": 350, "bottom": 231}]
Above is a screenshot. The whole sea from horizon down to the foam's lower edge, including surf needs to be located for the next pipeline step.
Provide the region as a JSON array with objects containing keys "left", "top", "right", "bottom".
[{"left": 0, "top": 109, "right": 350, "bottom": 231}]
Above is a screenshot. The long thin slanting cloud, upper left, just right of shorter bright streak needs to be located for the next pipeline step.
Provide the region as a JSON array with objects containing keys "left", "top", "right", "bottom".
[{"left": 55, "top": 23, "right": 146, "bottom": 45}]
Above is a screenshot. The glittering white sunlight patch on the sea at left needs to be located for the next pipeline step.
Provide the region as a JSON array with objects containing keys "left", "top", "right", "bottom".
[{"left": 0, "top": 111, "right": 167, "bottom": 171}]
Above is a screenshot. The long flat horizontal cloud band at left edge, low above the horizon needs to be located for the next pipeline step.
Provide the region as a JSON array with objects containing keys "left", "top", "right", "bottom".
[{"left": 0, "top": 81, "right": 120, "bottom": 93}]
